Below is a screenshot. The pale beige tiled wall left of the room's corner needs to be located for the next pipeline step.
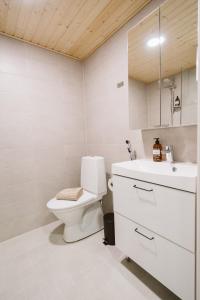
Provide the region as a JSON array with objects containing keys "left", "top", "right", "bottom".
[{"left": 0, "top": 36, "right": 85, "bottom": 241}]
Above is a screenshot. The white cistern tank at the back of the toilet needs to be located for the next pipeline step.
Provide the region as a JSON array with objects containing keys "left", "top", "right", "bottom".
[{"left": 81, "top": 156, "right": 107, "bottom": 196}]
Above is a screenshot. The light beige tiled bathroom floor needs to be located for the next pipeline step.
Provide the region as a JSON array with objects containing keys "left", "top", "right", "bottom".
[{"left": 0, "top": 222, "right": 178, "bottom": 300}]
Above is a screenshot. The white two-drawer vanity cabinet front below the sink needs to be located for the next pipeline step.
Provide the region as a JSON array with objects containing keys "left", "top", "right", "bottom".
[{"left": 113, "top": 175, "right": 196, "bottom": 300}]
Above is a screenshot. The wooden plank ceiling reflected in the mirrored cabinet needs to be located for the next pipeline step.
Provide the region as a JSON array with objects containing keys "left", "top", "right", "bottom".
[{"left": 128, "top": 0, "right": 198, "bottom": 83}]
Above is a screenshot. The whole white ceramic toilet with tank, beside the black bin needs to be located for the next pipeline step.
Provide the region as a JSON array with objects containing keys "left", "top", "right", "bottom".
[{"left": 47, "top": 156, "right": 107, "bottom": 242}]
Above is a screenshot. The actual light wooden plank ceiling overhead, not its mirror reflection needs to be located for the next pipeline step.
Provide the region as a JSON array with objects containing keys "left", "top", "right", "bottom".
[{"left": 0, "top": 0, "right": 151, "bottom": 59}]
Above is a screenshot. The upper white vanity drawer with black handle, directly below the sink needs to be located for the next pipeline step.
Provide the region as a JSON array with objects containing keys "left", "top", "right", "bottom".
[{"left": 113, "top": 176, "right": 195, "bottom": 252}]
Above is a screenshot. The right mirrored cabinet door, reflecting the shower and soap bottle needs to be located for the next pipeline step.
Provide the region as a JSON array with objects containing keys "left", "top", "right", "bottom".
[{"left": 160, "top": 0, "right": 198, "bottom": 126}]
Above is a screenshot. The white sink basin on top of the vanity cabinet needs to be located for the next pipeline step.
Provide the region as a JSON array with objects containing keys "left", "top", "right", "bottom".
[{"left": 112, "top": 159, "right": 197, "bottom": 193}]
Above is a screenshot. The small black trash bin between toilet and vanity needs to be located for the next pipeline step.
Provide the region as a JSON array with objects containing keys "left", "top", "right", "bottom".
[{"left": 103, "top": 213, "right": 115, "bottom": 245}]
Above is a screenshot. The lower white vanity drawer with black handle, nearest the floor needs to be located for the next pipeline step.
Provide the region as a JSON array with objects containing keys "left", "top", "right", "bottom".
[{"left": 115, "top": 213, "right": 195, "bottom": 300}]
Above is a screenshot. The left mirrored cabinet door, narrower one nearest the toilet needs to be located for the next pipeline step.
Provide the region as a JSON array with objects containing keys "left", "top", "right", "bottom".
[{"left": 128, "top": 9, "right": 160, "bottom": 129}]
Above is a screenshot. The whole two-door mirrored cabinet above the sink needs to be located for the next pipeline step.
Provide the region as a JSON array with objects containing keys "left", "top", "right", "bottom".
[{"left": 128, "top": 0, "right": 197, "bottom": 129}]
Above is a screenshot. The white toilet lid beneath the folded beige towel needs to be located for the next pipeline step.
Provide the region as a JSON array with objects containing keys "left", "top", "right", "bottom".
[{"left": 47, "top": 191, "right": 97, "bottom": 210}]
